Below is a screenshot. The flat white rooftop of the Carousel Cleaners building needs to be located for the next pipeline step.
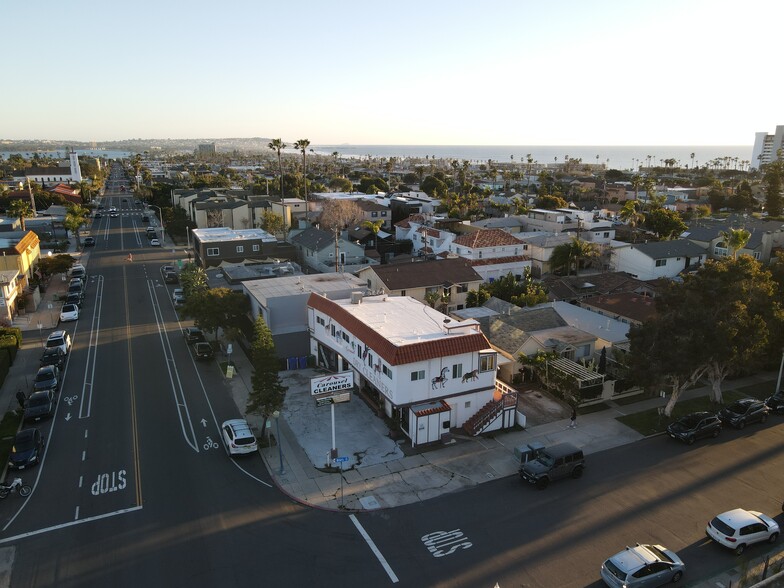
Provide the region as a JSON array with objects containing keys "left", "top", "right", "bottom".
[{"left": 333, "top": 296, "right": 479, "bottom": 346}]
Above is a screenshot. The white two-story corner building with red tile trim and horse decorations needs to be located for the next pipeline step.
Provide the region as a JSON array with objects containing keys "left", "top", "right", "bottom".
[{"left": 308, "top": 293, "right": 517, "bottom": 446}]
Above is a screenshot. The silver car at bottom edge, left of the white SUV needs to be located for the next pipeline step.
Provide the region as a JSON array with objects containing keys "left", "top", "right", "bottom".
[{"left": 601, "top": 543, "right": 686, "bottom": 588}]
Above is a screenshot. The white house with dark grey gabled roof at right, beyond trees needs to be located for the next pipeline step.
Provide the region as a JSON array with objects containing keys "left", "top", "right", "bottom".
[{"left": 610, "top": 239, "right": 708, "bottom": 280}]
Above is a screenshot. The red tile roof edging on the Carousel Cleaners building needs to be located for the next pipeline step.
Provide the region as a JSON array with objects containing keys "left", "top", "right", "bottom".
[{"left": 308, "top": 294, "right": 490, "bottom": 365}]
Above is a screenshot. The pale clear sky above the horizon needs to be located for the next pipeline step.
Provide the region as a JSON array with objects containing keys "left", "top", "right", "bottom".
[{"left": 7, "top": 0, "right": 784, "bottom": 145}]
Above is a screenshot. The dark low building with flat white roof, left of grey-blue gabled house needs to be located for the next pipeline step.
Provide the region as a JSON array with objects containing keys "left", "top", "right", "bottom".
[{"left": 191, "top": 227, "right": 280, "bottom": 268}]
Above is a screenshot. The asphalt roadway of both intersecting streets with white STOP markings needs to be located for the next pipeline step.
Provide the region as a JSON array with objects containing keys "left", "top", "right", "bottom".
[{"left": 0, "top": 167, "right": 784, "bottom": 588}]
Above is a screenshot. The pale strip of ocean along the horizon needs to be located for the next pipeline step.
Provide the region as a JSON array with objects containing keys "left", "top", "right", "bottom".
[{"left": 313, "top": 144, "right": 753, "bottom": 169}]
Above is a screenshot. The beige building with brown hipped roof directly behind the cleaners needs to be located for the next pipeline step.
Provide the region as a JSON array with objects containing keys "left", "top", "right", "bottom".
[{"left": 357, "top": 257, "right": 483, "bottom": 314}]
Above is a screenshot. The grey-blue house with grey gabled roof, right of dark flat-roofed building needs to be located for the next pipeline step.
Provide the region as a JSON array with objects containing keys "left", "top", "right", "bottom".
[{"left": 289, "top": 227, "right": 378, "bottom": 273}]
